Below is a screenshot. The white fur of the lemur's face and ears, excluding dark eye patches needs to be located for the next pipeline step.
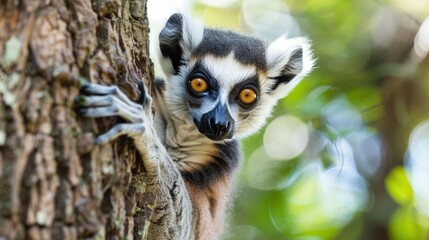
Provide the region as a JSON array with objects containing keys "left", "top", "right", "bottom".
[{"left": 161, "top": 18, "right": 314, "bottom": 142}]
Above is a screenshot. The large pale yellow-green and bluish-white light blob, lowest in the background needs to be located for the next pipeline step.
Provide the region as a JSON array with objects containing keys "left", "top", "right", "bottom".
[{"left": 270, "top": 160, "right": 368, "bottom": 234}]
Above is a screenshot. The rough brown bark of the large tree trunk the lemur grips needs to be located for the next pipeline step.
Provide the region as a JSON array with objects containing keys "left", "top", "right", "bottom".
[{"left": 0, "top": 0, "right": 155, "bottom": 239}]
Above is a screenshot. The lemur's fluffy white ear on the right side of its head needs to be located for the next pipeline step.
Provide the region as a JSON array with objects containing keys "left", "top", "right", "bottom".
[{"left": 266, "top": 36, "right": 315, "bottom": 99}]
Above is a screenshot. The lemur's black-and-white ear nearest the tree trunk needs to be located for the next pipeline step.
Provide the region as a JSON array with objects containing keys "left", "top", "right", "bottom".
[{"left": 159, "top": 13, "right": 204, "bottom": 75}]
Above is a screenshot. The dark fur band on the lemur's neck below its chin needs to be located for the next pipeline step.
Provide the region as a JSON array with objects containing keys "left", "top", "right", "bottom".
[{"left": 181, "top": 141, "right": 241, "bottom": 188}]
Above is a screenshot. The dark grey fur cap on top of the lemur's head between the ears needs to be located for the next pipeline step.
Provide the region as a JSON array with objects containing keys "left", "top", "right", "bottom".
[{"left": 193, "top": 28, "right": 267, "bottom": 70}]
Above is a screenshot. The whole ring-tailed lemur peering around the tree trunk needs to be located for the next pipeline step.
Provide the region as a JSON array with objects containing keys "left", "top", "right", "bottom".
[{"left": 80, "top": 14, "right": 314, "bottom": 239}]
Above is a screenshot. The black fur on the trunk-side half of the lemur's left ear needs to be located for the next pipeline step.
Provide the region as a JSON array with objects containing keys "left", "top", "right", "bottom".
[{"left": 159, "top": 13, "right": 183, "bottom": 75}]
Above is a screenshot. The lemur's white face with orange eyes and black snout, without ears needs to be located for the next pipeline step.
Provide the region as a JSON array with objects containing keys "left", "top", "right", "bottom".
[{"left": 182, "top": 52, "right": 261, "bottom": 140}]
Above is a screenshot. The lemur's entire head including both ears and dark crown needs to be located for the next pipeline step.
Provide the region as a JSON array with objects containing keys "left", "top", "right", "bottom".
[{"left": 159, "top": 14, "right": 314, "bottom": 141}]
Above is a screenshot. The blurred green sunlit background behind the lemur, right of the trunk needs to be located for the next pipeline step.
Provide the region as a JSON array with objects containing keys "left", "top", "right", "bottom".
[{"left": 148, "top": 0, "right": 429, "bottom": 240}]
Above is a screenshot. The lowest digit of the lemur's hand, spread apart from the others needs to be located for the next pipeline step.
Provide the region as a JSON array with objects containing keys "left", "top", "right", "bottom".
[{"left": 95, "top": 123, "right": 145, "bottom": 145}]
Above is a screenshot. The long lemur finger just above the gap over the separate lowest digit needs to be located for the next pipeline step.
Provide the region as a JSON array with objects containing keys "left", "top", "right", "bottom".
[{"left": 79, "top": 105, "right": 143, "bottom": 123}]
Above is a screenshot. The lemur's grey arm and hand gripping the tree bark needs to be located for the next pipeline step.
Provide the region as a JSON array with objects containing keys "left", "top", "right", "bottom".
[{"left": 79, "top": 84, "right": 195, "bottom": 239}]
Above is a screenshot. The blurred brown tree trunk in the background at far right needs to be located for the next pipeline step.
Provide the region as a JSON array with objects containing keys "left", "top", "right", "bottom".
[{"left": 359, "top": 13, "right": 429, "bottom": 239}]
